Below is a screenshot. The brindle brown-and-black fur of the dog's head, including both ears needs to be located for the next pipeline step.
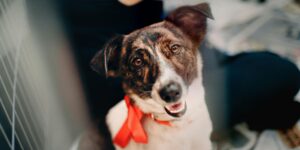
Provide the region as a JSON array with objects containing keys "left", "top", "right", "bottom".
[{"left": 92, "top": 3, "right": 212, "bottom": 99}]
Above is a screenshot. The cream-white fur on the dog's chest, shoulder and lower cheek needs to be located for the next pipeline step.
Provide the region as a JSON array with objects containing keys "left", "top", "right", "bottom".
[{"left": 106, "top": 54, "right": 212, "bottom": 150}]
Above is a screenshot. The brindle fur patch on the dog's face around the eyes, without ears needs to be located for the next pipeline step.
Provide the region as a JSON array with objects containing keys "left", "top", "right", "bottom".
[{"left": 121, "top": 22, "right": 197, "bottom": 98}]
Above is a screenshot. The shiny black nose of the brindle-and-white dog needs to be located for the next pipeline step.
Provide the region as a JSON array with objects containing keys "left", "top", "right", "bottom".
[{"left": 159, "top": 82, "right": 181, "bottom": 102}]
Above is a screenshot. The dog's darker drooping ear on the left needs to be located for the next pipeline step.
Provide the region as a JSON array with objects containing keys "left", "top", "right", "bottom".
[{"left": 90, "top": 35, "right": 124, "bottom": 77}]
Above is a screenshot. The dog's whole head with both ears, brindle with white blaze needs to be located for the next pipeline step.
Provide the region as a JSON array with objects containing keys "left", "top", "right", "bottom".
[{"left": 91, "top": 3, "right": 212, "bottom": 118}]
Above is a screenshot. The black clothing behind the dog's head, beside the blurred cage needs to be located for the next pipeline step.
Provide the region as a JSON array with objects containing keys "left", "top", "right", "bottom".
[{"left": 57, "top": 0, "right": 162, "bottom": 118}]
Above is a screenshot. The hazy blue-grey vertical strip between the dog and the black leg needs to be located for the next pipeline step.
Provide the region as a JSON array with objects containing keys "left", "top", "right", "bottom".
[{"left": 200, "top": 42, "right": 229, "bottom": 130}]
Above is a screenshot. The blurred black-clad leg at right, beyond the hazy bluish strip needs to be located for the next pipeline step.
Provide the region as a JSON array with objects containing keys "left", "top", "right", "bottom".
[{"left": 226, "top": 52, "right": 300, "bottom": 130}]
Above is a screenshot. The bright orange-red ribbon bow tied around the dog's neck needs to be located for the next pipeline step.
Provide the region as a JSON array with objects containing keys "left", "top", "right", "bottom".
[{"left": 114, "top": 96, "right": 171, "bottom": 148}]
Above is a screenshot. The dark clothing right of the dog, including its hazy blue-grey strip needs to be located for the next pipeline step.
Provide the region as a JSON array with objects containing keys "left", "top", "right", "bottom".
[{"left": 201, "top": 47, "right": 300, "bottom": 130}]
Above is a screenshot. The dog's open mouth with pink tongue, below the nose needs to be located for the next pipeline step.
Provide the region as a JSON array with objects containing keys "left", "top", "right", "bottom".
[{"left": 164, "top": 102, "right": 187, "bottom": 118}]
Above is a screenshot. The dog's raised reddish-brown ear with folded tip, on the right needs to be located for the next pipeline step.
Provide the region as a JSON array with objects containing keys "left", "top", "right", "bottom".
[{"left": 165, "top": 3, "right": 214, "bottom": 44}]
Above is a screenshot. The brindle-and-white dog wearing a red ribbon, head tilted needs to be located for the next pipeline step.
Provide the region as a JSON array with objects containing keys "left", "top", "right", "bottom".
[{"left": 91, "top": 3, "right": 213, "bottom": 150}]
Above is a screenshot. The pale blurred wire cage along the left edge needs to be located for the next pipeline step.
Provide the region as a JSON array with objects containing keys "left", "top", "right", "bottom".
[{"left": 0, "top": 0, "right": 88, "bottom": 150}]
